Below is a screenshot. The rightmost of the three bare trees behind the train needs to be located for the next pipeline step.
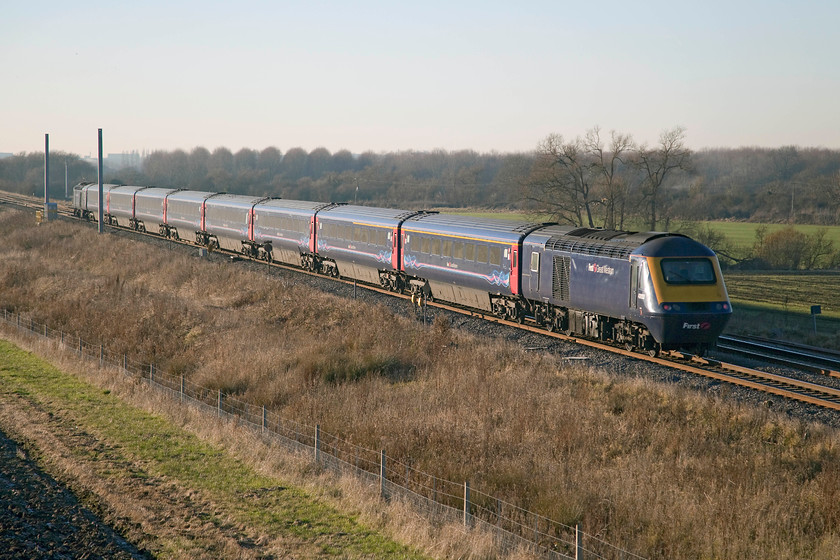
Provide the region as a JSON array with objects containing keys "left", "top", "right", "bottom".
[{"left": 638, "top": 126, "right": 691, "bottom": 230}]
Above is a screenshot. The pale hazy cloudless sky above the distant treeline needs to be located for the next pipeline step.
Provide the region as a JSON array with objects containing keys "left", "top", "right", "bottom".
[{"left": 0, "top": 0, "right": 840, "bottom": 155}]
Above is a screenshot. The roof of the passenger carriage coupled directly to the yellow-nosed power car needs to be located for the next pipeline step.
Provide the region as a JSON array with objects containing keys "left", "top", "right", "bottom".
[{"left": 403, "top": 213, "right": 546, "bottom": 243}]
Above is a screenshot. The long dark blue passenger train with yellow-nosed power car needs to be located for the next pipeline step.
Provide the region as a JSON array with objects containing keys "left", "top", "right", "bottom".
[{"left": 73, "top": 183, "right": 732, "bottom": 356}]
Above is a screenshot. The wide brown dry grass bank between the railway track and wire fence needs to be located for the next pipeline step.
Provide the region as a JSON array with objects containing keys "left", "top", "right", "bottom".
[{"left": 0, "top": 208, "right": 840, "bottom": 559}]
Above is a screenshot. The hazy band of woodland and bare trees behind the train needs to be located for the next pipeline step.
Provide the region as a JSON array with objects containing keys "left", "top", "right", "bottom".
[{"left": 0, "top": 127, "right": 840, "bottom": 236}]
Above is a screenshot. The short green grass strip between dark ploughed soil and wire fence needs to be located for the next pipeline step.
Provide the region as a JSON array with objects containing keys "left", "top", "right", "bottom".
[{"left": 0, "top": 340, "right": 420, "bottom": 558}]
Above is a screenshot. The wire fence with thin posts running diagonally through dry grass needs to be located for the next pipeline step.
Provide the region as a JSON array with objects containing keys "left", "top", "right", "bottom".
[{"left": 3, "top": 308, "right": 642, "bottom": 560}]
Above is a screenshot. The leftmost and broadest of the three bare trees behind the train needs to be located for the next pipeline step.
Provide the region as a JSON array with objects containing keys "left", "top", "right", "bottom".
[{"left": 525, "top": 134, "right": 600, "bottom": 227}]
